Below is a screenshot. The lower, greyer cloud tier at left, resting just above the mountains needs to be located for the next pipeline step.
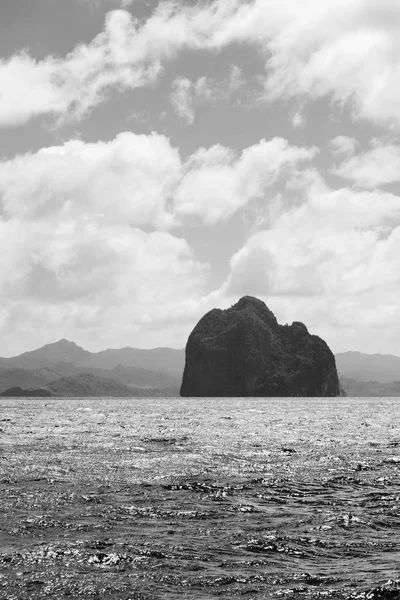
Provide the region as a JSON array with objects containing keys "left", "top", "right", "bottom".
[{"left": 0, "top": 220, "right": 208, "bottom": 353}]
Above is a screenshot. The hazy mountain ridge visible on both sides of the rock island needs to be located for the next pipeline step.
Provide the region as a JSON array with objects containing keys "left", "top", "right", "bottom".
[{"left": 0, "top": 338, "right": 400, "bottom": 396}]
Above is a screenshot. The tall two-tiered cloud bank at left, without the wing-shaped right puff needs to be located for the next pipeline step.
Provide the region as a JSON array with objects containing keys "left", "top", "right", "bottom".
[{"left": 0, "top": 133, "right": 208, "bottom": 352}]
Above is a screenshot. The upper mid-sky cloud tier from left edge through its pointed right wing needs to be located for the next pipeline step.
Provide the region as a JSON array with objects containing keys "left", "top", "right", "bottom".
[{"left": 0, "top": 132, "right": 317, "bottom": 230}]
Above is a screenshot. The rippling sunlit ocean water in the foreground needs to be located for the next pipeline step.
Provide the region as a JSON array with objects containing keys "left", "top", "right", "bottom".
[{"left": 0, "top": 398, "right": 400, "bottom": 600}]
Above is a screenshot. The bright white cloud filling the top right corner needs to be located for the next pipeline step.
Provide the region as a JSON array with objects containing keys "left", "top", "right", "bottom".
[{"left": 219, "top": 0, "right": 400, "bottom": 123}]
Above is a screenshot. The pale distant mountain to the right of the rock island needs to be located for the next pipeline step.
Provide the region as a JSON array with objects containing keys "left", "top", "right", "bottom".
[{"left": 335, "top": 352, "right": 400, "bottom": 384}]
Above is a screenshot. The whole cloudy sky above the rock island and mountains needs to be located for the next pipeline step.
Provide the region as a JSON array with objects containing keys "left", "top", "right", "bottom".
[{"left": 0, "top": 0, "right": 400, "bottom": 356}]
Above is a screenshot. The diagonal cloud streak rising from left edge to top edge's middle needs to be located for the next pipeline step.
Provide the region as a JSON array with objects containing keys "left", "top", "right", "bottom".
[{"left": 0, "top": 2, "right": 241, "bottom": 127}]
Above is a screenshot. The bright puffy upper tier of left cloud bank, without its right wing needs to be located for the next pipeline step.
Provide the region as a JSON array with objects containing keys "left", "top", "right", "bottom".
[{"left": 0, "top": 132, "right": 181, "bottom": 228}]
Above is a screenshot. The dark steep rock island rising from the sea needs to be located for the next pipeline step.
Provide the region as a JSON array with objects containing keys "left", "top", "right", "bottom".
[{"left": 181, "top": 296, "right": 340, "bottom": 396}]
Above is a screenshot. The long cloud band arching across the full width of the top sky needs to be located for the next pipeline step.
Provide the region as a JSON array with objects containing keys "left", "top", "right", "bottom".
[{"left": 4, "top": 0, "right": 400, "bottom": 125}]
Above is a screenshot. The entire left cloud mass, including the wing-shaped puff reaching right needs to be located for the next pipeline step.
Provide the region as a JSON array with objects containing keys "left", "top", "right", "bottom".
[{"left": 0, "top": 132, "right": 316, "bottom": 351}]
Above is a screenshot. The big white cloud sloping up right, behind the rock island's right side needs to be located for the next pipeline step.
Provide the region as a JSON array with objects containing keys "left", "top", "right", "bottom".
[{"left": 215, "top": 172, "right": 400, "bottom": 353}]
